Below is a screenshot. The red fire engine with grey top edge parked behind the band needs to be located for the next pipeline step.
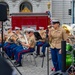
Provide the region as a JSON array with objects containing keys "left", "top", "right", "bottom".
[{"left": 11, "top": 13, "right": 50, "bottom": 29}]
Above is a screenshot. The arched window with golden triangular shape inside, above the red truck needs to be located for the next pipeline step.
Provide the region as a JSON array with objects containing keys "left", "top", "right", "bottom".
[{"left": 20, "top": 1, "right": 32, "bottom": 12}]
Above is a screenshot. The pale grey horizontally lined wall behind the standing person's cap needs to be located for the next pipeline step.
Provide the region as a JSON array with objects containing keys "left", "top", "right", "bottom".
[{"left": 51, "top": 0, "right": 75, "bottom": 24}]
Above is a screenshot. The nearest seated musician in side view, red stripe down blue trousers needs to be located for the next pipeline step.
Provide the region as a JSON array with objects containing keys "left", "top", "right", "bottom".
[{"left": 14, "top": 28, "right": 36, "bottom": 67}]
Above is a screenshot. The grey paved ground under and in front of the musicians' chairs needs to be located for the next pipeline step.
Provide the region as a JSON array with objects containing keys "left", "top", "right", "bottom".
[{"left": 7, "top": 48, "right": 52, "bottom": 75}]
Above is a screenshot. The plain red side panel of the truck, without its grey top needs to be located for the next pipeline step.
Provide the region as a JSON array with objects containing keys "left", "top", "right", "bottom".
[{"left": 11, "top": 15, "right": 49, "bottom": 29}]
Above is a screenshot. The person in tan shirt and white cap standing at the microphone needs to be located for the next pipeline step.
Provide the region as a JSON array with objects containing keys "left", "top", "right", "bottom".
[{"left": 49, "top": 20, "right": 68, "bottom": 71}]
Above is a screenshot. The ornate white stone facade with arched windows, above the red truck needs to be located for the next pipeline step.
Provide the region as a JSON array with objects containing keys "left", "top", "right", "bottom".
[{"left": 0, "top": 0, "right": 49, "bottom": 14}]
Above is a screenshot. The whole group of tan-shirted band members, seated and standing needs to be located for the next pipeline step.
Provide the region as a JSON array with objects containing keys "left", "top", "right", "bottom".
[{"left": 0, "top": 20, "right": 72, "bottom": 71}]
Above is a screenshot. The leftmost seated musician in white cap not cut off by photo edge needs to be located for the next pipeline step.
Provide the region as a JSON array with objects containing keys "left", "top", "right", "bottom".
[{"left": 3, "top": 27, "right": 16, "bottom": 58}]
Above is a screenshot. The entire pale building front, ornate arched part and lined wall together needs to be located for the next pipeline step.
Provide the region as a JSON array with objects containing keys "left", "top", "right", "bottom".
[{"left": 0, "top": 0, "right": 75, "bottom": 24}]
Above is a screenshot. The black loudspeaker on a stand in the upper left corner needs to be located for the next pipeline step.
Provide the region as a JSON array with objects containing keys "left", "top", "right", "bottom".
[{"left": 0, "top": 4, "right": 7, "bottom": 21}]
